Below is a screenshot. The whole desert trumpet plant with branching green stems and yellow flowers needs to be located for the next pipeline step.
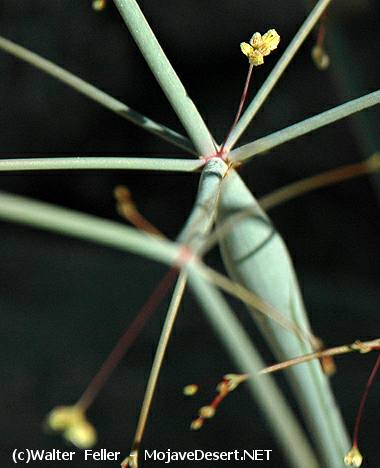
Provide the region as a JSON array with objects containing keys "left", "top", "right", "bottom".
[{"left": 0, "top": 0, "right": 380, "bottom": 468}]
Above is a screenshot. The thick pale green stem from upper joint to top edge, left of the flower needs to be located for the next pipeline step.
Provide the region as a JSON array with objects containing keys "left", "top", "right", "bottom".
[{"left": 114, "top": 0, "right": 215, "bottom": 156}]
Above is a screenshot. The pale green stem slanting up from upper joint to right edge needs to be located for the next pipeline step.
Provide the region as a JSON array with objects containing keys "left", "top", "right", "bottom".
[{"left": 230, "top": 91, "right": 380, "bottom": 162}]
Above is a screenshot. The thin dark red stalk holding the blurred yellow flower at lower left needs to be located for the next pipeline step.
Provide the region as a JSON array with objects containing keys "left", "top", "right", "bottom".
[{"left": 77, "top": 267, "right": 178, "bottom": 410}]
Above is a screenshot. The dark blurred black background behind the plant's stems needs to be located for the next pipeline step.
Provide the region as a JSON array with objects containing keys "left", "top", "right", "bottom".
[{"left": 0, "top": 0, "right": 380, "bottom": 467}]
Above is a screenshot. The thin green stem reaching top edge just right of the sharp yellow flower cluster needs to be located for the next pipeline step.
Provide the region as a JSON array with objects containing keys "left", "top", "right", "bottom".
[{"left": 225, "top": 0, "right": 331, "bottom": 152}]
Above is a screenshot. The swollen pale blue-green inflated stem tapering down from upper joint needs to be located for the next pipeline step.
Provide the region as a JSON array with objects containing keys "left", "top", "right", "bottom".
[{"left": 218, "top": 171, "right": 350, "bottom": 468}]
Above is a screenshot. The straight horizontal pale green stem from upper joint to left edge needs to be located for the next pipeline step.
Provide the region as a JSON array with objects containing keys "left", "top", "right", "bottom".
[{"left": 0, "top": 156, "right": 204, "bottom": 172}]
